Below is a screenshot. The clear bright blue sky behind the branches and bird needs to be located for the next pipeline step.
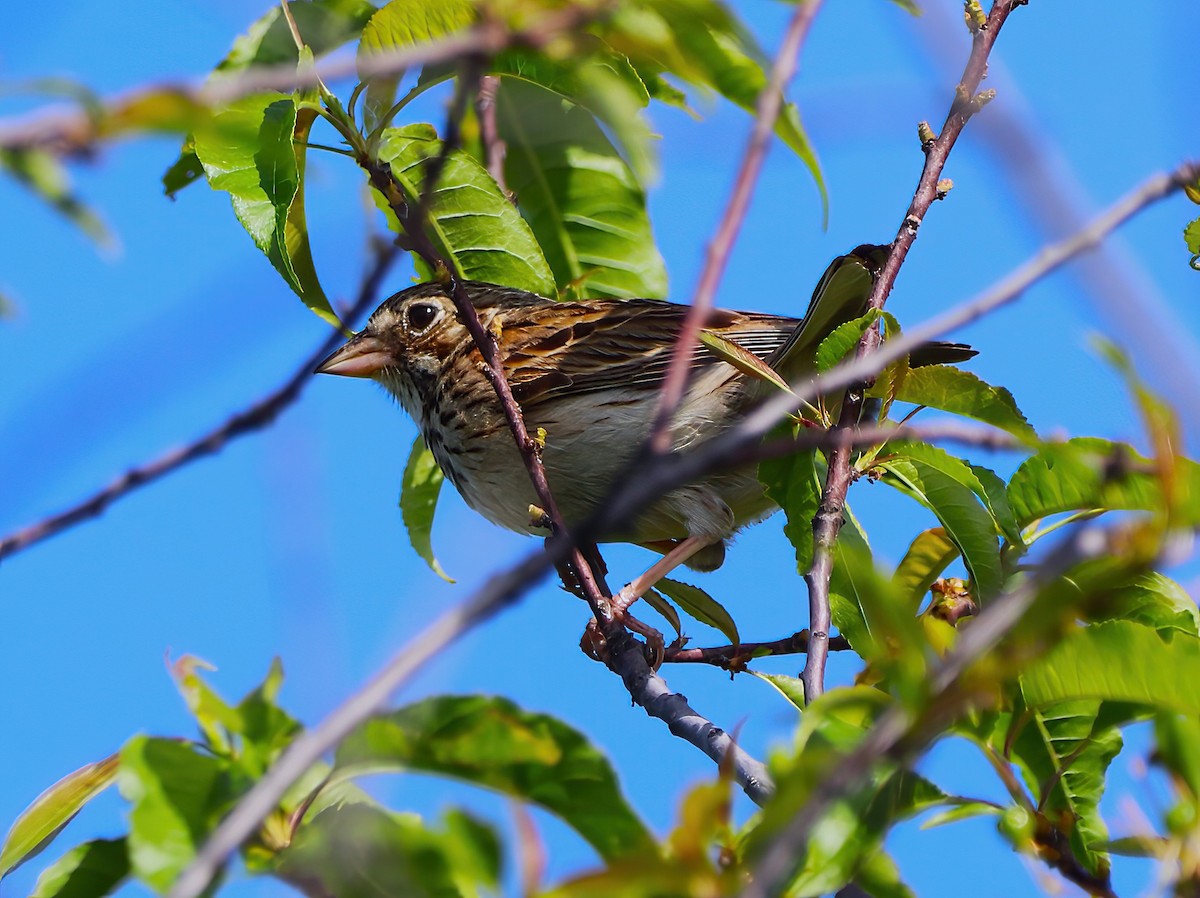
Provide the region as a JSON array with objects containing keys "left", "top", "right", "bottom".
[{"left": 0, "top": 0, "right": 1200, "bottom": 896}]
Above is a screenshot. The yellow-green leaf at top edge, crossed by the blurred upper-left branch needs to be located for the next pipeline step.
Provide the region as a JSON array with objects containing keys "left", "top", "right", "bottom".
[{"left": 358, "top": 0, "right": 476, "bottom": 132}]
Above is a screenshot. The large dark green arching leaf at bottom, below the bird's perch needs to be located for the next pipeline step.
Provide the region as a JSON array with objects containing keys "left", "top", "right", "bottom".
[{"left": 335, "top": 696, "right": 653, "bottom": 861}]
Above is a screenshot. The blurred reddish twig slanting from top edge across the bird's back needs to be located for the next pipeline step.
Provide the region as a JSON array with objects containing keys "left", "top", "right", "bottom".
[{"left": 649, "top": 0, "right": 821, "bottom": 454}]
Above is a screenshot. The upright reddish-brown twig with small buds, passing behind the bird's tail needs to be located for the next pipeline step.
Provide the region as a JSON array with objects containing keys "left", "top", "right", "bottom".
[{"left": 800, "top": 0, "right": 1015, "bottom": 701}]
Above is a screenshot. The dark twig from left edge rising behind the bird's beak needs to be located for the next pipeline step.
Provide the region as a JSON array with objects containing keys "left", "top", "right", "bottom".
[{"left": 0, "top": 241, "right": 398, "bottom": 559}]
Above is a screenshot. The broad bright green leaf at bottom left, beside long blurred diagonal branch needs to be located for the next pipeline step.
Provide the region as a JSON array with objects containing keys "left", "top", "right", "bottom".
[{"left": 116, "top": 736, "right": 233, "bottom": 892}]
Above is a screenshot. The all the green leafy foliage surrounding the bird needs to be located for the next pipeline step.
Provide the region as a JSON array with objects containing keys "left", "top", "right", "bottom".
[{"left": 0, "top": 0, "right": 1200, "bottom": 898}]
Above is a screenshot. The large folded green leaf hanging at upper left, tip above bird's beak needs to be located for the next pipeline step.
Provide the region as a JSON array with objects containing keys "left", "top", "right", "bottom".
[{"left": 194, "top": 94, "right": 338, "bottom": 325}]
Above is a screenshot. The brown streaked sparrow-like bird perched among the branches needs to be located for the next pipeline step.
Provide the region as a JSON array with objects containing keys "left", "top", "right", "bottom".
[{"left": 316, "top": 245, "right": 976, "bottom": 605}]
